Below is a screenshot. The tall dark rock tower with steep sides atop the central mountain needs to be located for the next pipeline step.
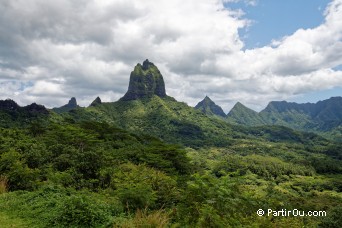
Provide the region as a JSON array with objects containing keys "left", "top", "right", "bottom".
[{"left": 120, "top": 59, "right": 166, "bottom": 101}]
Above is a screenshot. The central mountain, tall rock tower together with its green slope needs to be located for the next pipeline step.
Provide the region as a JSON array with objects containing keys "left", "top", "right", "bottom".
[{"left": 60, "top": 59, "right": 232, "bottom": 146}]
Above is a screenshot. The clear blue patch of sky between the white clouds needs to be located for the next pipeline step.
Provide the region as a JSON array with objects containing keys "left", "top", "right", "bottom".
[{"left": 225, "top": 0, "right": 329, "bottom": 49}]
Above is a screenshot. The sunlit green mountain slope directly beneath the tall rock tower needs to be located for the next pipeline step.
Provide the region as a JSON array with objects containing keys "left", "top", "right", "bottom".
[{"left": 65, "top": 95, "right": 233, "bottom": 146}]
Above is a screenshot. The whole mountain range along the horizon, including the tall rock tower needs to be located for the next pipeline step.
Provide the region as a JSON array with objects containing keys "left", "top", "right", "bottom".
[{"left": 0, "top": 60, "right": 342, "bottom": 146}]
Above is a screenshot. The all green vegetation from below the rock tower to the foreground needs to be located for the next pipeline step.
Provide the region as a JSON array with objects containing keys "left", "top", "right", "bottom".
[{"left": 0, "top": 96, "right": 342, "bottom": 227}]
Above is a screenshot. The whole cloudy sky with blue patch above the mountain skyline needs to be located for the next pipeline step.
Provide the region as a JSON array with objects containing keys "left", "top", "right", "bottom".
[{"left": 0, "top": 0, "right": 342, "bottom": 112}]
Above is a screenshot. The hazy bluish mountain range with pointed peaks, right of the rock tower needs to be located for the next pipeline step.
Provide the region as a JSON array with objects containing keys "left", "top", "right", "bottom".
[{"left": 195, "top": 94, "right": 342, "bottom": 140}]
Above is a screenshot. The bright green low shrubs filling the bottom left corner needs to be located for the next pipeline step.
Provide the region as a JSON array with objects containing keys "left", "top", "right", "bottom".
[{"left": 0, "top": 186, "right": 123, "bottom": 227}]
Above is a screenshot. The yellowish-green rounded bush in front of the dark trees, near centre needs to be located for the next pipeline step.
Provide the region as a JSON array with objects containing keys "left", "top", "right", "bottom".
[{"left": 111, "top": 163, "right": 179, "bottom": 211}]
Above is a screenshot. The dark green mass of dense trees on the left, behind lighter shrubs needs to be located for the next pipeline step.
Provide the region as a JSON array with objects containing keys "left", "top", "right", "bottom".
[{"left": 0, "top": 122, "right": 189, "bottom": 190}]
